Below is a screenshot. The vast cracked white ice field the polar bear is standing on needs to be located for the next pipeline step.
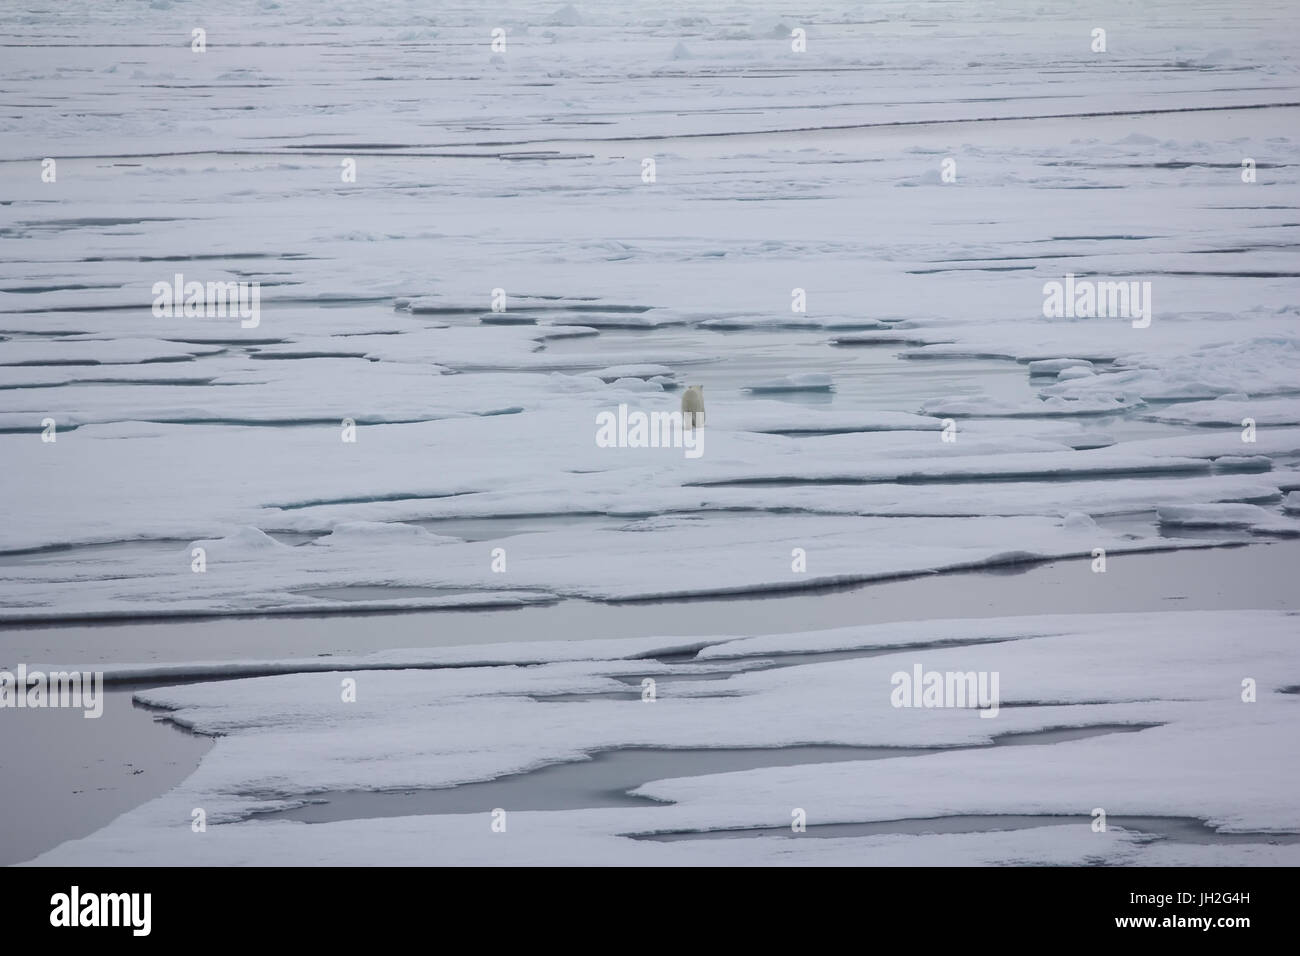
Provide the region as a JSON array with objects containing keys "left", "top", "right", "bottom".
[{"left": 0, "top": 0, "right": 1300, "bottom": 619}]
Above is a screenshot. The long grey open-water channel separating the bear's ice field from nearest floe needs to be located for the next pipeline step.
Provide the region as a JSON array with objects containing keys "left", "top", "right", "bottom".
[{"left": 0, "top": 540, "right": 1300, "bottom": 667}]
